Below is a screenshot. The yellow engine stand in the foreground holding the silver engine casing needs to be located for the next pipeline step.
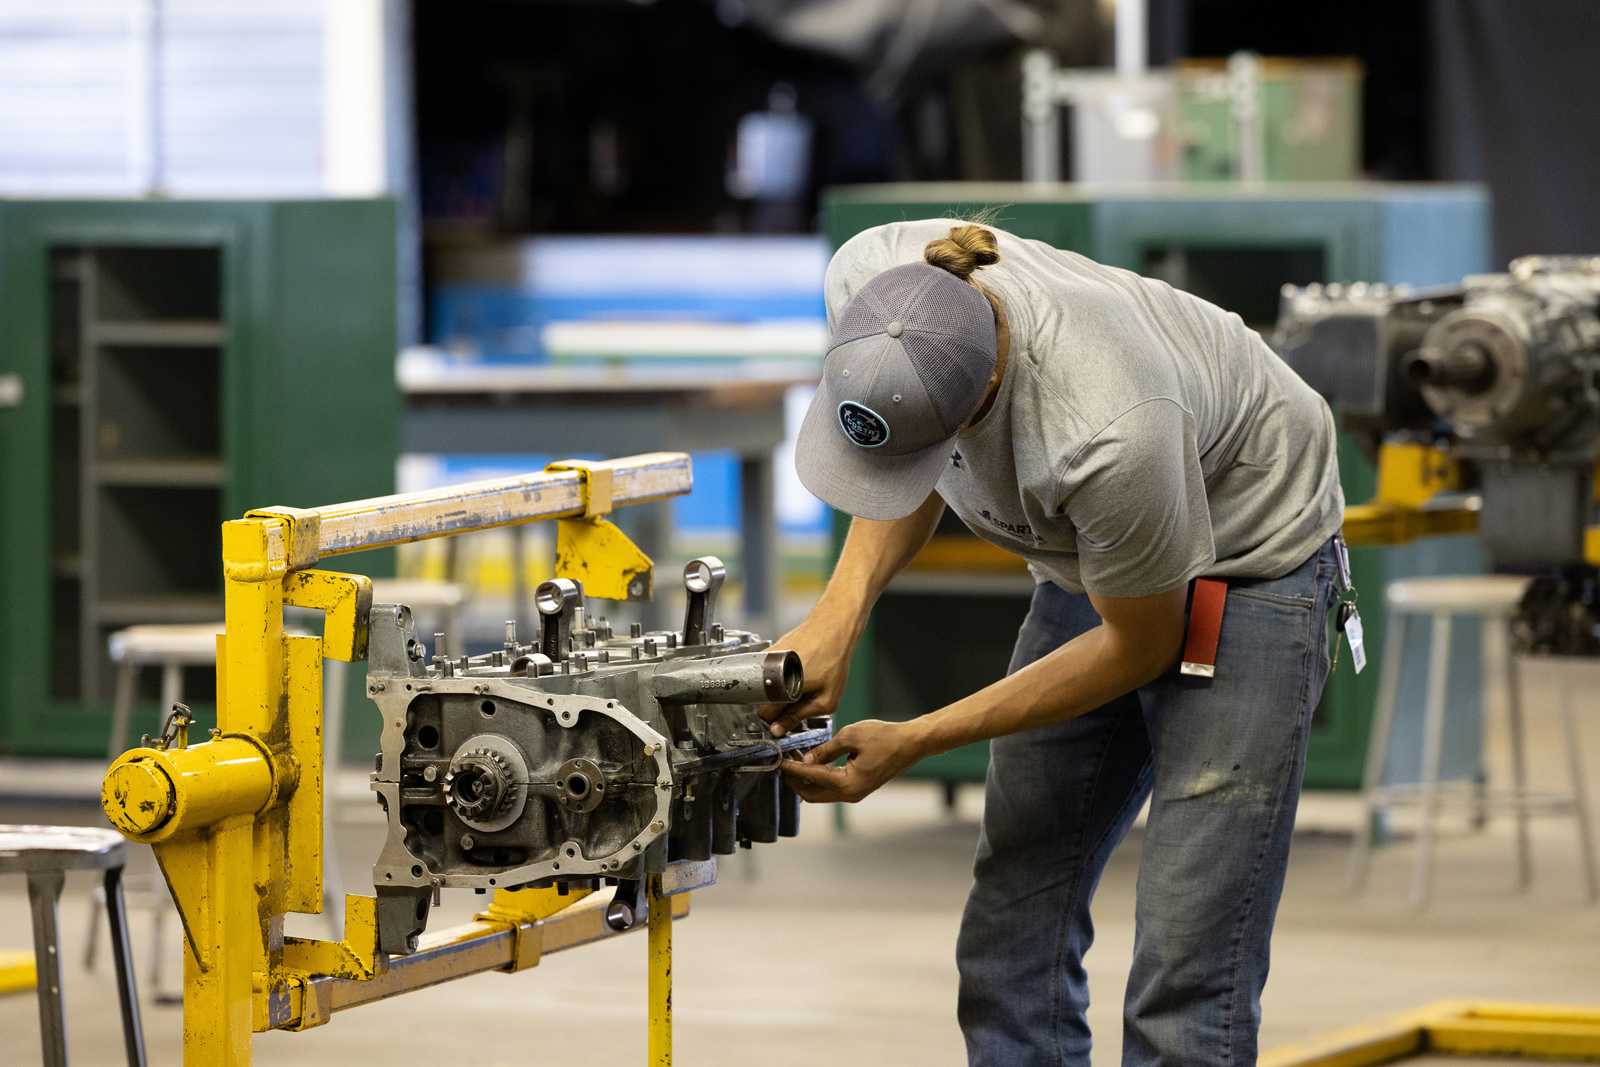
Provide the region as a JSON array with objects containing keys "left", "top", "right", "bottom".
[{"left": 101, "top": 453, "right": 694, "bottom": 1067}]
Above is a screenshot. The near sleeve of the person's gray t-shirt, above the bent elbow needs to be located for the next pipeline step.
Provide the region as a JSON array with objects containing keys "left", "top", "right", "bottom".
[{"left": 1059, "top": 397, "right": 1216, "bottom": 597}]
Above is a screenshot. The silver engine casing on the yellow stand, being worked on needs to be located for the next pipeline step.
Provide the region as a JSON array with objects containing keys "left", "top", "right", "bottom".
[{"left": 366, "top": 557, "right": 829, "bottom": 953}]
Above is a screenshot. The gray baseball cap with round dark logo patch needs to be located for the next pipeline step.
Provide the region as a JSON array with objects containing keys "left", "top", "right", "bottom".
[{"left": 795, "top": 262, "right": 995, "bottom": 518}]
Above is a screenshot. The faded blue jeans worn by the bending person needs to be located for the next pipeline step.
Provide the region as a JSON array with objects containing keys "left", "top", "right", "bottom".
[{"left": 957, "top": 541, "right": 1338, "bottom": 1067}]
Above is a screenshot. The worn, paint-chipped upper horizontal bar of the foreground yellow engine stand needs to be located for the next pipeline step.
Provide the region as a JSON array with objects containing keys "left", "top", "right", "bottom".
[{"left": 296, "top": 453, "right": 694, "bottom": 558}]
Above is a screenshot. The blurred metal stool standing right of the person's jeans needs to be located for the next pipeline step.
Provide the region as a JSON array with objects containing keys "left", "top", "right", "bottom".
[{"left": 1350, "top": 574, "right": 1597, "bottom": 907}]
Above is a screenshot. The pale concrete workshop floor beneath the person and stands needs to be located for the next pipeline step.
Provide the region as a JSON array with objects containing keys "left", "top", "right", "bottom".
[{"left": 0, "top": 677, "right": 1600, "bottom": 1067}]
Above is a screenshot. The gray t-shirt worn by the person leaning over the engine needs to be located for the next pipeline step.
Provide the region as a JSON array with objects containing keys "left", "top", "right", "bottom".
[{"left": 826, "top": 219, "right": 1344, "bottom": 597}]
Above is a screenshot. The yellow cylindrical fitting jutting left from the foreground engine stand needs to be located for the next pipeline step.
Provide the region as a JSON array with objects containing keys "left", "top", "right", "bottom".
[{"left": 101, "top": 737, "right": 274, "bottom": 845}]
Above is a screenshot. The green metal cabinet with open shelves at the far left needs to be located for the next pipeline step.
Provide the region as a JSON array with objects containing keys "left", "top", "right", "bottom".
[{"left": 0, "top": 200, "right": 400, "bottom": 755}]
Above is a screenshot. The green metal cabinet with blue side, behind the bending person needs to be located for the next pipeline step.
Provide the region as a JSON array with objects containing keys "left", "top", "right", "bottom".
[{"left": 822, "top": 182, "right": 1490, "bottom": 789}]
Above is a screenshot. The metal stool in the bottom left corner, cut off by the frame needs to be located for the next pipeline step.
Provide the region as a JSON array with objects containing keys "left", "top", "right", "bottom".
[{"left": 0, "top": 825, "right": 144, "bottom": 1067}]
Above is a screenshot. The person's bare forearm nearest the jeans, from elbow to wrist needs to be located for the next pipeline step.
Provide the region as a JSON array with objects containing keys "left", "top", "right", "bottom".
[{"left": 914, "top": 625, "right": 1178, "bottom": 758}]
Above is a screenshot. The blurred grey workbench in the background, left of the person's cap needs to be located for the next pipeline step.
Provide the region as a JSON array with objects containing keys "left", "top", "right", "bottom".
[{"left": 398, "top": 350, "right": 816, "bottom": 632}]
